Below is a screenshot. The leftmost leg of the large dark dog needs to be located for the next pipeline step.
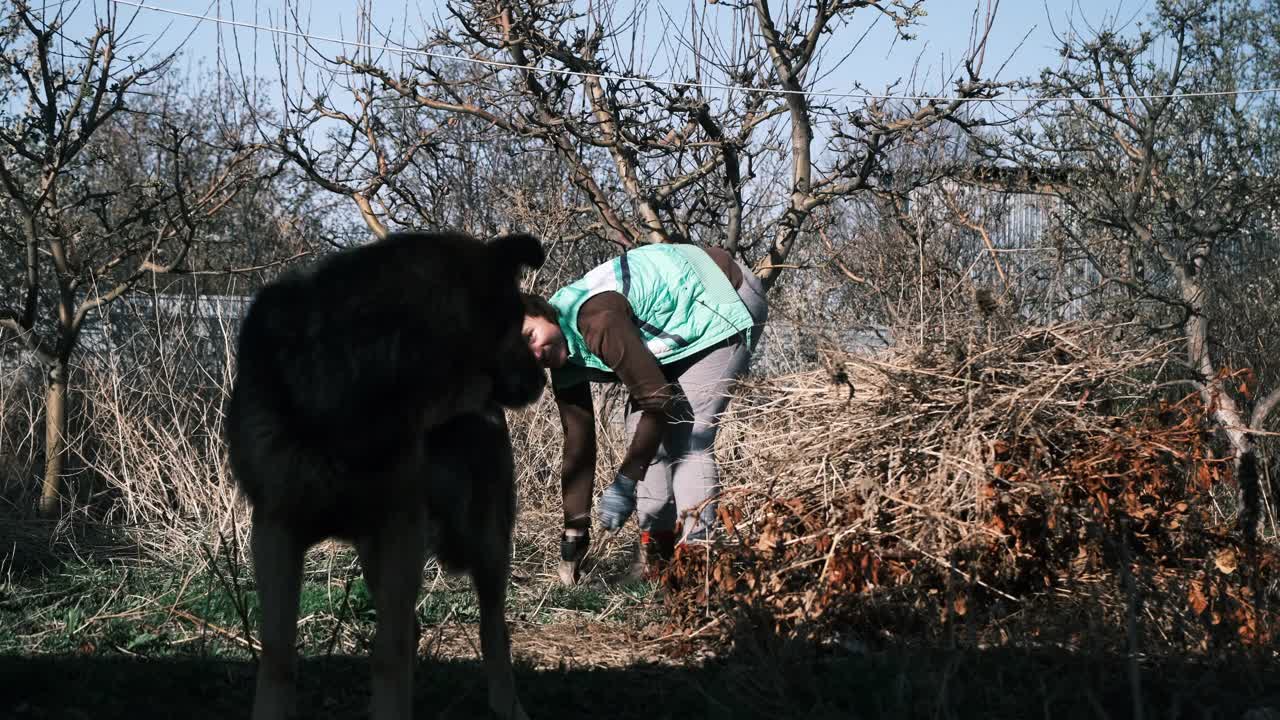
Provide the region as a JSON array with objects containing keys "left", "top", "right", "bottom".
[{"left": 250, "top": 518, "right": 306, "bottom": 720}]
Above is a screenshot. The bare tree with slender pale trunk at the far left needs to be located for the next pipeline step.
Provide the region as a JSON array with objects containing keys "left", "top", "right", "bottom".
[{"left": 0, "top": 0, "right": 262, "bottom": 515}]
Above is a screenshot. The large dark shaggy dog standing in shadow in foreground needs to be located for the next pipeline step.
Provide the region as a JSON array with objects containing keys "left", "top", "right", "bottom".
[{"left": 227, "top": 233, "right": 544, "bottom": 720}]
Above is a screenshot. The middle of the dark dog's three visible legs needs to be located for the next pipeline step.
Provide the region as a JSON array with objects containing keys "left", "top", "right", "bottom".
[{"left": 356, "top": 512, "right": 426, "bottom": 720}]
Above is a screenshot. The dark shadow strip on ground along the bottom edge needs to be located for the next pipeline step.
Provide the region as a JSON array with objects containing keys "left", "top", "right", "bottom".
[{"left": 0, "top": 640, "right": 1280, "bottom": 720}]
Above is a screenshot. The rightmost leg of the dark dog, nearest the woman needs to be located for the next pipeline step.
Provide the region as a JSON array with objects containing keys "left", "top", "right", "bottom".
[{"left": 471, "top": 552, "right": 529, "bottom": 720}]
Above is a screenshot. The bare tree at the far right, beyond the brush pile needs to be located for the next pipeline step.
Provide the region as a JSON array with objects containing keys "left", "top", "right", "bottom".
[{"left": 1015, "top": 0, "right": 1280, "bottom": 537}]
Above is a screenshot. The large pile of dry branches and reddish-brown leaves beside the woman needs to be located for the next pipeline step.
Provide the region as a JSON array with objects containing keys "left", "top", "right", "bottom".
[{"left": 663, "top": 323, "right": 1280, "bottom": 647}]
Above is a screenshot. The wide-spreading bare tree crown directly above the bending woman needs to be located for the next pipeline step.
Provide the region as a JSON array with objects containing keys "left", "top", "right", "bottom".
[{"left": 252, "top": 0, "right": 997, "bottom": 292}]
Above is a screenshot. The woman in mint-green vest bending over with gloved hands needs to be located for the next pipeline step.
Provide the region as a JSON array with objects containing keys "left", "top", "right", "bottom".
[{"left": 524, "top": 245, "right": 768, "bottom": 584}]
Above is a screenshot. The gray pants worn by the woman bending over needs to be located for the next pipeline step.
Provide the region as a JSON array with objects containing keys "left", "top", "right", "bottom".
[{"left": 626, "top": 263, "right": 768, "bottom": 539}]
